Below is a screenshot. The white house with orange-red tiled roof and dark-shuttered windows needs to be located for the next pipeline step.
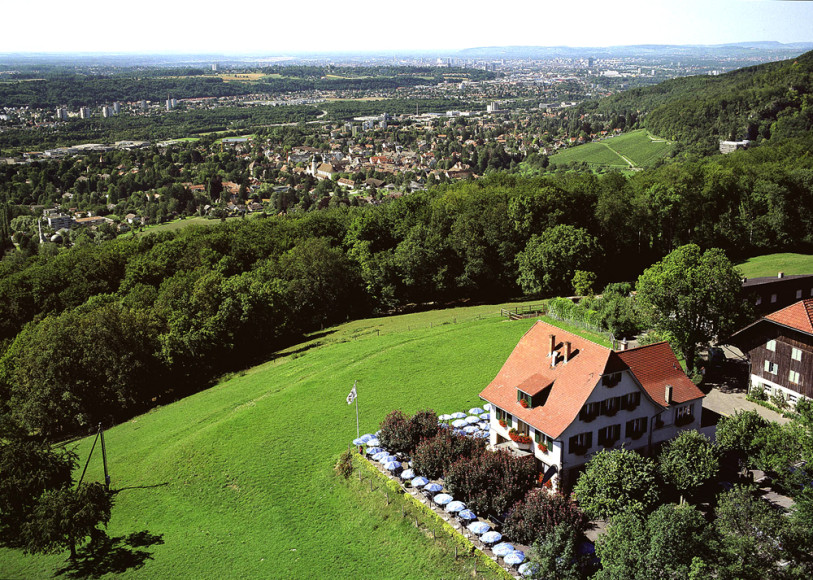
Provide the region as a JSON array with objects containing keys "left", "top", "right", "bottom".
[{"left": 480, "top": 321, "right": 704, "bottom": 490}]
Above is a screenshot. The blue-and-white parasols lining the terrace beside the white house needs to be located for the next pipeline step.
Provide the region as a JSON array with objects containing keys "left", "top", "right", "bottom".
[{"left": 353, "top": 405, "right": 534, "bottom": 576}]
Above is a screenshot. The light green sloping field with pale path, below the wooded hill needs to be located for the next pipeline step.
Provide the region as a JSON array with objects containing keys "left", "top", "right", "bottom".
[{"left": 550, "top": 130, "right": 673, "bottom": 169}]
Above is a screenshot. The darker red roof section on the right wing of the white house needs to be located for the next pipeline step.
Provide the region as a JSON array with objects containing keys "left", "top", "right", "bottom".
[{"left": 618, "top": 342, "right": 704, "bottom": 407}]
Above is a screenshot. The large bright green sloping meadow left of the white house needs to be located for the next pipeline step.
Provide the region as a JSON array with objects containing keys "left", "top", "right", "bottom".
[{"left": 0, "top": 306, "right": 596, "bottom": 579}]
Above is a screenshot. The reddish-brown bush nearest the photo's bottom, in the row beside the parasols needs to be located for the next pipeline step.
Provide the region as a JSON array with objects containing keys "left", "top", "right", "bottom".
[{"left": 505, "top": 489, "right": 588, "bottom": 545}]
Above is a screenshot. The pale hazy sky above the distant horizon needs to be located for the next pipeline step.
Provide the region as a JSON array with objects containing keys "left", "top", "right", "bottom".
[{"left": 6, "top": 0, "right": 813, "bottom": 55}]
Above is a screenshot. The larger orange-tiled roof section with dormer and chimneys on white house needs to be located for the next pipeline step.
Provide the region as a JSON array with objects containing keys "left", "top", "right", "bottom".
[{"left": 480, "top": 321, "right": 623, "bottom": 439}]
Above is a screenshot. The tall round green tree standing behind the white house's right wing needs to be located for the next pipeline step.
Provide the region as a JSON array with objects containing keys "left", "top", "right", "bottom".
[{"left": 636, "top": 244, "right": 744, "bottom": 371}]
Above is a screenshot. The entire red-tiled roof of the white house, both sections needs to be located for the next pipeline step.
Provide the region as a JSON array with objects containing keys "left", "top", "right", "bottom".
[{"left": 480, "top": 321, "right": 703, "bottom": 438}]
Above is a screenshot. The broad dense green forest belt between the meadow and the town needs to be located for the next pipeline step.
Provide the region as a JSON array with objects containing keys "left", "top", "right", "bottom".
[{"left": 0, "top": 129, "right": 813, "bottom": 438}]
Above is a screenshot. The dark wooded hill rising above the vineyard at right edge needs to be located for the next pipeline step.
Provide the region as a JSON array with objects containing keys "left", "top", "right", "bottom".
[{"left": 582, "top": 51, "right": 813, "bottom": 153}]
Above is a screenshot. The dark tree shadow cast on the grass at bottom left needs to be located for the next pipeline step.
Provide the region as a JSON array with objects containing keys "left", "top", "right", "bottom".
[{"left": 54, "top": 530, "right": 164, "bottom": 578}]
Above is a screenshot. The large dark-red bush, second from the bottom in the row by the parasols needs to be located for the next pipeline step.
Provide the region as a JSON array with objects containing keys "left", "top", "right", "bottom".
[{"left": 445, "top": 450, "right": 537, "bottom": 517}]
